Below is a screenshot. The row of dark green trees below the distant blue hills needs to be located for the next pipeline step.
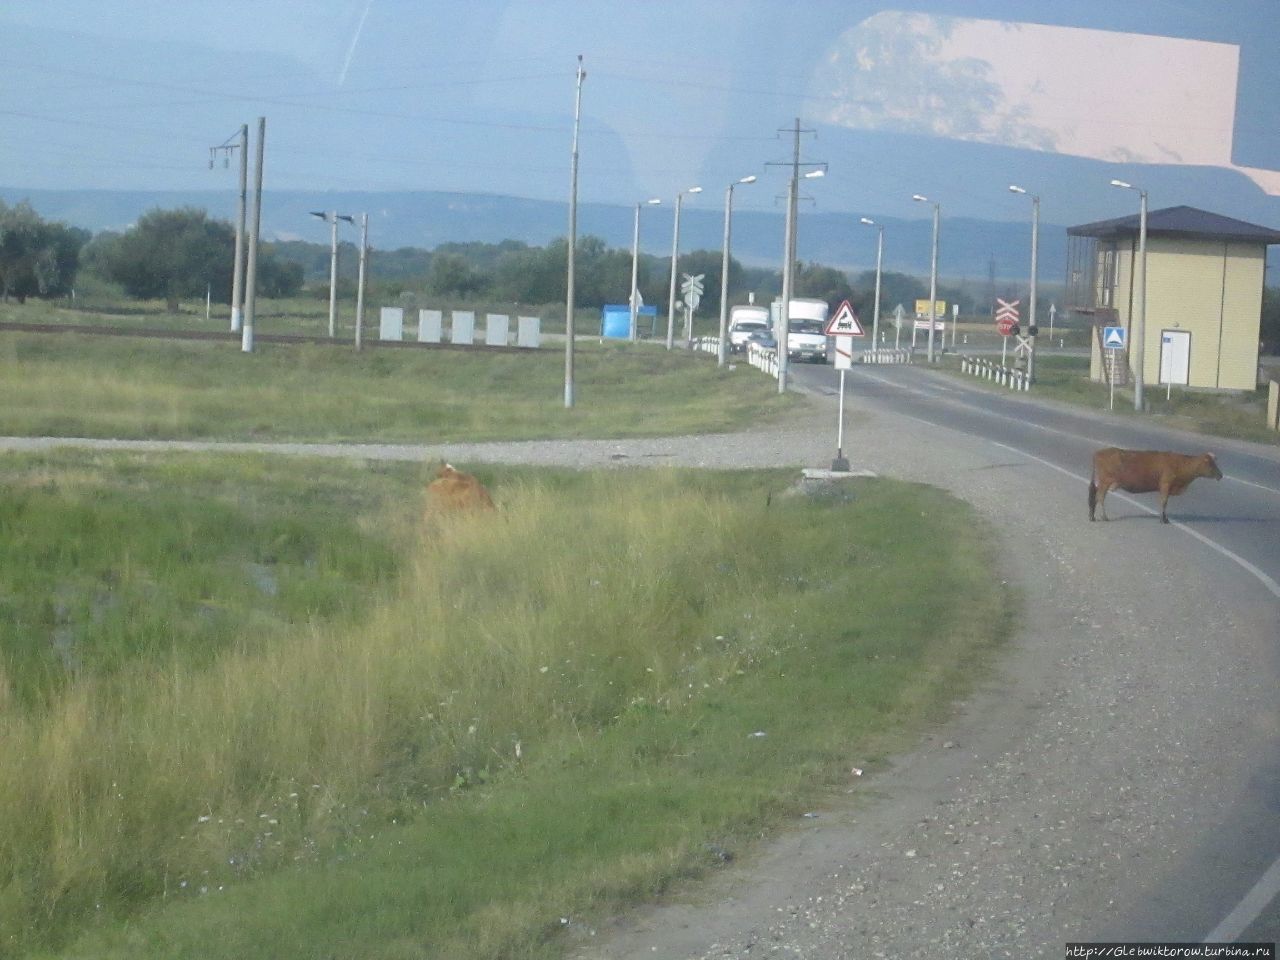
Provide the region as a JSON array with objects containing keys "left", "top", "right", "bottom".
[{"left": 0, "top": 202, "right": 1039, "bottom": 321}]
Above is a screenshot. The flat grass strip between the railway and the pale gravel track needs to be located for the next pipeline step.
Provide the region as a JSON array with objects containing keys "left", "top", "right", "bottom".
[{"left": 0, "top": 325, "right": 801, "bottom": 443}]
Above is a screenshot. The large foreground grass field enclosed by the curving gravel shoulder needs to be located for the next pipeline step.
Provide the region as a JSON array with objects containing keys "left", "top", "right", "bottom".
[{"left": 0, "top": 452, "right": 1010, "bottom": 960}]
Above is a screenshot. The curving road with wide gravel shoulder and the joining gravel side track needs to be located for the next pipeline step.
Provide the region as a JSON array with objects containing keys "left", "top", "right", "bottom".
[{"left": 4, "top": 366, "right": 1280, "bottom": 960}]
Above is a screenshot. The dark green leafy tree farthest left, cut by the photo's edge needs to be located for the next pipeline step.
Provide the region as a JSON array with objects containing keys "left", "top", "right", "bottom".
[{"left": 0, "top": 201, "right": 88, "bottom": 302}]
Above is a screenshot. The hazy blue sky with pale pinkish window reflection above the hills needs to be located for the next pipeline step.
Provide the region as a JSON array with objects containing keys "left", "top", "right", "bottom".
[{"left": 0, "top": 0, "right": 1280, "bottom": 227}]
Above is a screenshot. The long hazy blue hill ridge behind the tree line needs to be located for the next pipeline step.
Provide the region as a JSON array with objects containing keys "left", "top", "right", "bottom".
[{"left": 0, "top": 187, "right": 1131, "bottom": 283}]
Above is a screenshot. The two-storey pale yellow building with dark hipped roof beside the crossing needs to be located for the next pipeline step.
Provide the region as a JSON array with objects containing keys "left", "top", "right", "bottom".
[{"left": 1066, "top": 206, "right": 1280, "bottom": 390}]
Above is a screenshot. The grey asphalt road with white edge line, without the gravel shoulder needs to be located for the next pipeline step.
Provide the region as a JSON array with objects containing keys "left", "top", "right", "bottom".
[{"left": 792, "top": 366, "right": 1280, "bottom": 941}]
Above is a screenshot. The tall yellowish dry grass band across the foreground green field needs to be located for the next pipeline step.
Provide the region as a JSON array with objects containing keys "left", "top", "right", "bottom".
[{"left": 0, "top": 474, "right": 780, "bottom": 943}]
